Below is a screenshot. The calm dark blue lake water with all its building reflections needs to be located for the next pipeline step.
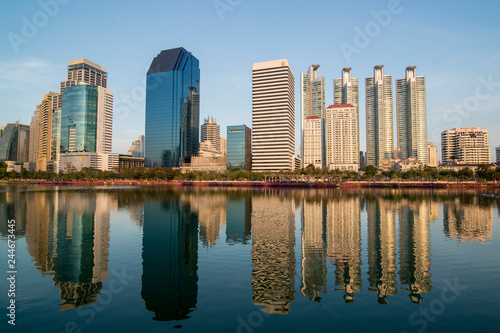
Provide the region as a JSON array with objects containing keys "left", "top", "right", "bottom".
[{"left": 0, "top": 187, "right": 500, "bottom": 332}]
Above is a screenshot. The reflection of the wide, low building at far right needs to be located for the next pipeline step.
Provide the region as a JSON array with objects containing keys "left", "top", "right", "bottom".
[{"left": 443, "top": 197, "right": 493, "bottom": 242}]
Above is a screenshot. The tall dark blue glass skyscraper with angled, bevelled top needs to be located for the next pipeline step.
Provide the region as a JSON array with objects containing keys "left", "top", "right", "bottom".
[{"left": 144, "top": 47, "right": 200, "bottom": 168}]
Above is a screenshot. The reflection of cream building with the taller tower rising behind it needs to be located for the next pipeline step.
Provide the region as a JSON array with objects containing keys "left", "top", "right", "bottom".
[{"left": 326, "top": 194, "right": 362, "bottom": 303}]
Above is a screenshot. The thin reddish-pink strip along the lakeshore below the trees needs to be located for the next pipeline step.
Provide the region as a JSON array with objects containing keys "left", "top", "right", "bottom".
[{"left": 0, "top": 179, "right": 500, "bottom": 188}]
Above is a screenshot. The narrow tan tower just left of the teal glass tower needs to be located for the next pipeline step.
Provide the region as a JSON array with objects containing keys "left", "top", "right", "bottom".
[{"left": 36, "top": 92, "right": 59, "bottom": 171}]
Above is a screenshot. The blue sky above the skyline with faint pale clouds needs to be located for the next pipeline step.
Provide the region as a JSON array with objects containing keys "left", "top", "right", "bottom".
[{"left": 0, "top": 0, "right": 500, "bottom": 160}]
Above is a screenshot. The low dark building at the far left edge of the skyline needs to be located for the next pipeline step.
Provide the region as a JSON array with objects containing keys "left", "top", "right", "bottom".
[{"left": 0, "top": 121, "right": 30, "bottom": 163}]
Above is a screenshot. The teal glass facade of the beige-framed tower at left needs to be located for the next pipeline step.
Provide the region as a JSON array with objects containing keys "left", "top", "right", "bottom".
[{"left": 61, "top": 84, "right": 97, "bottom": 153}]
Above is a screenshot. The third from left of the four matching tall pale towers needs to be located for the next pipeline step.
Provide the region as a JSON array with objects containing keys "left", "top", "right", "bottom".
[{"left": 365, "top": 65, "right": 394, "bottom": 166}]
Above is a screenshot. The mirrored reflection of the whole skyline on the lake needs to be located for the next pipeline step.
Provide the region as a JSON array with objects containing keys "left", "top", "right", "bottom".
[{"left": 0, "top": 188, "right": 498, "bottom": 321}]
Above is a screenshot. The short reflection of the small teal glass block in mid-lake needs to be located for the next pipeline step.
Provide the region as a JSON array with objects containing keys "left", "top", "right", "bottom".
[{"left": 226, "top": 192, "right": 252, "bottom": 244}]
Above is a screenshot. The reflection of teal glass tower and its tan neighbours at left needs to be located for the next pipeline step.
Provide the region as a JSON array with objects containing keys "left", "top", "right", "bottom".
[{"left": 26, "top": 191, "right": 116, "bottom": 310}]
